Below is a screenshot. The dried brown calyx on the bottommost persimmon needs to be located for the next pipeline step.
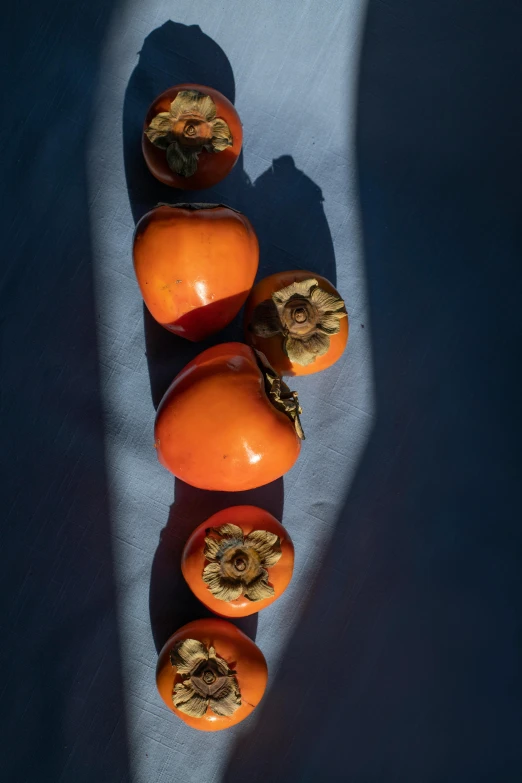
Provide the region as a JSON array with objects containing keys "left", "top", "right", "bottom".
[{"left": 170, "top": 639, "right": 241, "bottom": 718}]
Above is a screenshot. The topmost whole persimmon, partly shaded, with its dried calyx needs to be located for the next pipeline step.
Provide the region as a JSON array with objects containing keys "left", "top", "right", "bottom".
[{"left": 142, "top": 84, "right": 243, "bottom": 190}]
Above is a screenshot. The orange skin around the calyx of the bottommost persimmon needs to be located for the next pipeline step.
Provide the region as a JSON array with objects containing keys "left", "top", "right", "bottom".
[{"left": 156, "top": 618, "right": 268, "bottom": 731}]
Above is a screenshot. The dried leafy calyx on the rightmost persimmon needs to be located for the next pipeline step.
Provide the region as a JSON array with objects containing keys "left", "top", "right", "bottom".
[{"left": 249, "top": 278, "right": 346, "bottom": 367}]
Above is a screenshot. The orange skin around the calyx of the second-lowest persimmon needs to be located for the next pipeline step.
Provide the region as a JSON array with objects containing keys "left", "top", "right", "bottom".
[{"left": 181, "top": 506, "right": 294, "bottom": 617}]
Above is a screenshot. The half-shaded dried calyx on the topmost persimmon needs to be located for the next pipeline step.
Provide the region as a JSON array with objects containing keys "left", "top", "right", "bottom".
[{"left": 145, "top": 90, "right": 233, "bottom": 177}]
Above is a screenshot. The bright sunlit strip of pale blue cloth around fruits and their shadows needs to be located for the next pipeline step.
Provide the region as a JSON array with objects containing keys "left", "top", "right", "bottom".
[{"left": 87, "top": 0, "right": 375, "bottom": 783}]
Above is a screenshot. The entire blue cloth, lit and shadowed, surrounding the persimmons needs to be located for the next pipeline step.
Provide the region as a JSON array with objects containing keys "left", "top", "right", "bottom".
[{"left": 0, "top": 0, "right": 522, "bottom": 783}]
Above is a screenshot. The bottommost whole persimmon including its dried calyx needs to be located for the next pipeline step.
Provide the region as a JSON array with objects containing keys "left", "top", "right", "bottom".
[{"left": 156, "top": 617, "right": 268, "bottom": 731}]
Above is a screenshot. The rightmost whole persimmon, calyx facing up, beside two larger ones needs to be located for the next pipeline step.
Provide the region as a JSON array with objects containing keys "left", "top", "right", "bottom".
[{"left": 245, "top": 270, "right": 348, "bottom": 375}]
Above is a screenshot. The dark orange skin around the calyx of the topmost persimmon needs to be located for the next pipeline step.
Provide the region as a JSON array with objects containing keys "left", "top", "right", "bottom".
[{"left": 142, "top": 83, "right": 243, "bottom": 190}]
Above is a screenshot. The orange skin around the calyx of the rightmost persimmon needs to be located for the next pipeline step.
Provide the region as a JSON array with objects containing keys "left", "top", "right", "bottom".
[{"left": 245, "top": 269, "right": 348, "bottom": 375}]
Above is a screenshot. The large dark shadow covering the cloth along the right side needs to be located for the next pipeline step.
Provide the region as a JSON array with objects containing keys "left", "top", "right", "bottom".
[{"left": 223, "top": 0, "right": 522, "bottom": 783}]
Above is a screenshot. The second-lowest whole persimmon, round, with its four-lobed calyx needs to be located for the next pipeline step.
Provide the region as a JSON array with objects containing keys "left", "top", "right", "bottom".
[{"left": 181, "top": 506, "right": 294, "bottom": 617}]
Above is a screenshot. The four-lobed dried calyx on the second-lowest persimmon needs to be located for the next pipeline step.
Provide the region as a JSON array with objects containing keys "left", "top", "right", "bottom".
[{"left": 203, "top": 523, "right": 282, "bottom": 601}]
